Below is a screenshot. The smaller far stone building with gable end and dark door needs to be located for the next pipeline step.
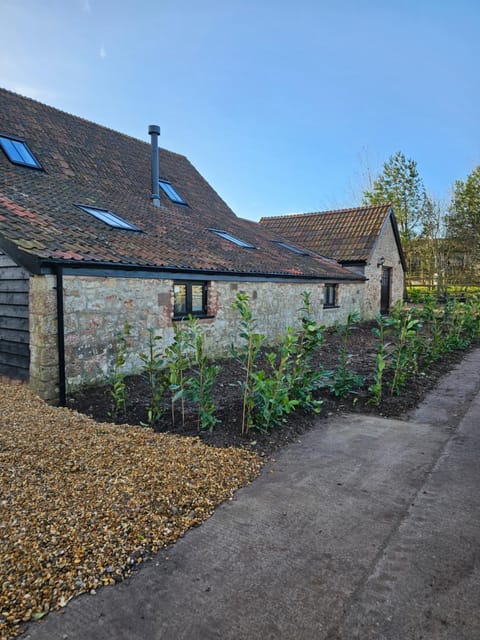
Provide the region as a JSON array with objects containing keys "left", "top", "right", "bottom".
[{"left": 260, "top": 204, "right": 406, "bottom": 318}]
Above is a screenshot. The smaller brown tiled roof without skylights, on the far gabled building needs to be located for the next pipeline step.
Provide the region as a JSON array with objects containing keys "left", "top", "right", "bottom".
[{"left": 260, "top": 204, "right": 400, "bottom": 262}]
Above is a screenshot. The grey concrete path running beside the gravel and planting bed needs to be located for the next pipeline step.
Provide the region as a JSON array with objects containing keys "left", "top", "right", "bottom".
[{"left": 26, "top": 350, "right": 480, "bottom": 640}]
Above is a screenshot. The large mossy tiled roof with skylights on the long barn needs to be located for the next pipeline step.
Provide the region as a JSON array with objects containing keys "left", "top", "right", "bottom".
[{"left": 0, "top": 89, "right": 355, "bottom": 279}]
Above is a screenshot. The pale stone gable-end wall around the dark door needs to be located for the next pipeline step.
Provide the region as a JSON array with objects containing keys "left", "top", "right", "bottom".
[{"left": 363, "top": 219, "right": 404, "bottom": 320}]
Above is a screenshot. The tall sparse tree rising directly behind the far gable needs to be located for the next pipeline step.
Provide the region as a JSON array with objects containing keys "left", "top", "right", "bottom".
[{"left": 363, "top": 151, "right": 426, "bottom": 241}]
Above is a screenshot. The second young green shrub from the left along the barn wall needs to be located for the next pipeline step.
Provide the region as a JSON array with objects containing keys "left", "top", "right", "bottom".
[{"left": 139, "top": 329, "right": 168, "bottom": 427}]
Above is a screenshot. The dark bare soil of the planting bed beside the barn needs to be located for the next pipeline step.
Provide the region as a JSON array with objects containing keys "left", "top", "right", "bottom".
[{"left": 67, "top": 323, "right": 472, "bottom": 456}]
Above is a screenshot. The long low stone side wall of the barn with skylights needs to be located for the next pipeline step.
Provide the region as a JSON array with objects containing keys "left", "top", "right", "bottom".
[{"left": 30, "top": 276, "right": 364, "bottom": 402}]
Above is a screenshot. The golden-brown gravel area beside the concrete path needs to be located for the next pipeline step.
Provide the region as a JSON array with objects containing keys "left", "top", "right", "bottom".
[{"left": 0, "top": 386, "right": 261, "bottom": 640}]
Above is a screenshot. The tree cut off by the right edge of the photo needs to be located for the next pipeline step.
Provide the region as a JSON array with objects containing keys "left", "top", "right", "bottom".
[{"left": 447, "top": 166, "right": 480, "bottom": 284}]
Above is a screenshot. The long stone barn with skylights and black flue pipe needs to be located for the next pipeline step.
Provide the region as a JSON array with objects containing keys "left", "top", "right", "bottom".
[{"left": 0, "top": 90, "right": 392, "bottom": 403}]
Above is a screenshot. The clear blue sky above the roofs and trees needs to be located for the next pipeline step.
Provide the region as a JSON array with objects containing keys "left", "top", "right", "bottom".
[{"left": 0, "top": 0, "right": 480, "bottom": 220}]
